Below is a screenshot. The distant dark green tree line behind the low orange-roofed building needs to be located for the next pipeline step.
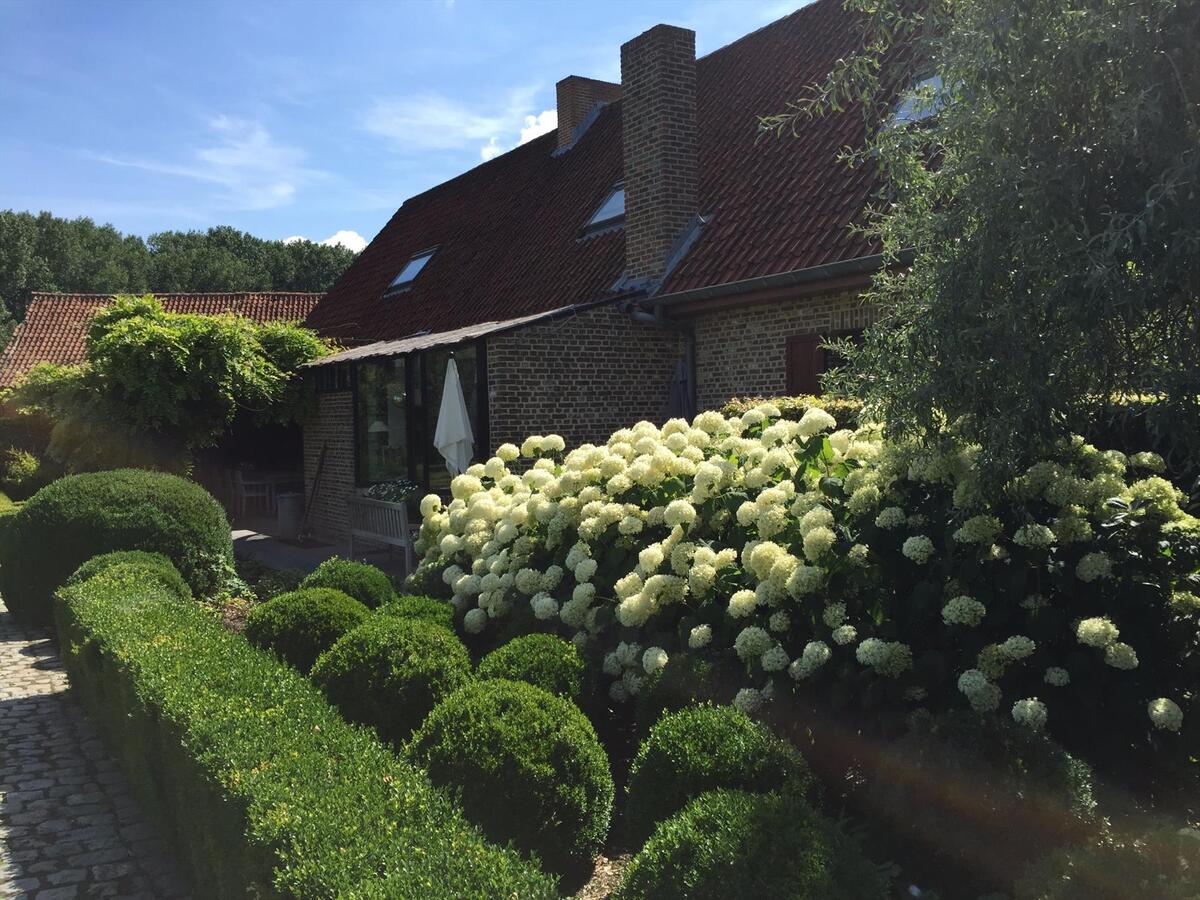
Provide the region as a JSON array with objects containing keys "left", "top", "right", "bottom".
[{"left": 0, "top": 210, "right": 355, "bottom": 319}]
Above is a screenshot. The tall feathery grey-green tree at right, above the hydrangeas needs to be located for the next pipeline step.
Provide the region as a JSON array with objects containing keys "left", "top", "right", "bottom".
[{"left": 764, "top": 0, "right": 1200, "bottom": 487}]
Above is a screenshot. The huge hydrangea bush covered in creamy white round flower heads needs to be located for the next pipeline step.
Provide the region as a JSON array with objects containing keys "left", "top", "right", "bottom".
[{"left": 414, "top": 402, "right": 1200, "bottom": 740}]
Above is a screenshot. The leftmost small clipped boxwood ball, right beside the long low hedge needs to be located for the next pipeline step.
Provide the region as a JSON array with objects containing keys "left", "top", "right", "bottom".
[{"left": 246, "top": 588, "right": 371, "bottom": 672}]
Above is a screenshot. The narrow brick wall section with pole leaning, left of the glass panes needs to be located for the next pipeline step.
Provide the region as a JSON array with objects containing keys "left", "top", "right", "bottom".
[{"left": 304, "top": 391, "right": 354, "bottom": 541}]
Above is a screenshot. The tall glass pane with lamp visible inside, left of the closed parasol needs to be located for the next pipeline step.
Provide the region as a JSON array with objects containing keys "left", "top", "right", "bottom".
[{"left": 358, "top": 356, "right": 409, "bottom": 485}]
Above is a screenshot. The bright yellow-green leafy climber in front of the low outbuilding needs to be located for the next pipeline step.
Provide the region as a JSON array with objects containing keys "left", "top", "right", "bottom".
[{"left": 11, "top": 295, "right": 329, "bottom": 470}]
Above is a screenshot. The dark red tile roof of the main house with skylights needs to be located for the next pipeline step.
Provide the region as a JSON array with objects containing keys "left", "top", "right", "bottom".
[{"left": 308, "top": 0, "right": 892, "bottom": 342}]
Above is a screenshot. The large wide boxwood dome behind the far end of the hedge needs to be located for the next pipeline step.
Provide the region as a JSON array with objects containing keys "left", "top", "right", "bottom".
[{"left": 0, "top": 469, "right": 233, "bottom": 624}]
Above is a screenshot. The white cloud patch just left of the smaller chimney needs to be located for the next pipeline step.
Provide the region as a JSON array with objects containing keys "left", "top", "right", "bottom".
[{"left": 364, "top": 88, "right": 558, "bottom": 162}]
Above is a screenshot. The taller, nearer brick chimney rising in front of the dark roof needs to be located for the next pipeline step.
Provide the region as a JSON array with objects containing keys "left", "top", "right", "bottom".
[{"left": 620, "top": 25, "right": 697, "bottom": 283}]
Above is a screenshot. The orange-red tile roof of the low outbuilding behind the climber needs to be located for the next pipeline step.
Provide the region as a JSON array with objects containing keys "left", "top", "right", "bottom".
[{"left": 0, "top": 292, "right": 320, "bottom": 388}]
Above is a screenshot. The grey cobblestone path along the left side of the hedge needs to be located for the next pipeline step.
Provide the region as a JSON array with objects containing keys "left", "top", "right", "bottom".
[{"left": 0, "top": 601, "right": 187, "bottom": 900}]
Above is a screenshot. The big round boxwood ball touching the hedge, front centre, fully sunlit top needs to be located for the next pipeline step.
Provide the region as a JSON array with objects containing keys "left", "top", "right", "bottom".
[{"left": 408, "top": 679, "right": 613, "bottom": 874}]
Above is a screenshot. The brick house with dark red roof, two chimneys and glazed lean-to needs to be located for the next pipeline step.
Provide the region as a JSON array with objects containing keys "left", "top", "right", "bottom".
[{"left": 305, "top": 0, "right": 897, "bottom": 536}]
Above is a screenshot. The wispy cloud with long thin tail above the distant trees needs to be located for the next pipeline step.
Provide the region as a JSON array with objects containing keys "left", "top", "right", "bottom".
[{"left": 89, "top": 115, "right": 328, "bottom": 210}]
